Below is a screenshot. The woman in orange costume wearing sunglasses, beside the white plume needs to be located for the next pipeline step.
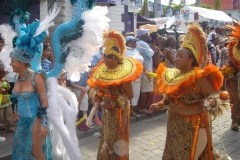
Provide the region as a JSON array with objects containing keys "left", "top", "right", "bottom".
[{"left": 88, "top": 31, "right": 143, "bottom": 160}]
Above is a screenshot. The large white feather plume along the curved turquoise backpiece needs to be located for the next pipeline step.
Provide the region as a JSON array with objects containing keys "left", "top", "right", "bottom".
[{"left": 65, "top": 6, "right": 110, "bottom": 81}]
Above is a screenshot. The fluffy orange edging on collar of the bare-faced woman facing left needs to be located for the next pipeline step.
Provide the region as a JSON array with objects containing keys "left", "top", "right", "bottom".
[{"left": 156, "top": 63, "right": 223, "bottom": 98}]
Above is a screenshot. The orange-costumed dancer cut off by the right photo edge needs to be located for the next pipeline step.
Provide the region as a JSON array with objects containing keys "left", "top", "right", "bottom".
[{"left": 221, "top": 22, "right": 240, "bottom": 131}]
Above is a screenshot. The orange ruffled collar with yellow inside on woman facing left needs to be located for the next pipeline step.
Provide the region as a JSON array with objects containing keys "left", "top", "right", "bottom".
[{"left": 156, "top": 63, "right": 223, "bottom": 98}]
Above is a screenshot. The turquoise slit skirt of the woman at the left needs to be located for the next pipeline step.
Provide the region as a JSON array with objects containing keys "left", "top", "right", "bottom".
[{"left": 12, "top": 117, "right": 53, "bottom": 160}]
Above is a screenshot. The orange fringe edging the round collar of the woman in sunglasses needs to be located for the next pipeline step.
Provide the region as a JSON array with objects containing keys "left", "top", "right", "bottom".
[{"left": 88, "top": 58, "right": 143, "bottom": 88}]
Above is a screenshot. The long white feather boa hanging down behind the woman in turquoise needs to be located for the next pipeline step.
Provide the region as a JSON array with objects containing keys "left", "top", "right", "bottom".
[{"left": 47, "top": 77, "right": 82, "bottom": 160}]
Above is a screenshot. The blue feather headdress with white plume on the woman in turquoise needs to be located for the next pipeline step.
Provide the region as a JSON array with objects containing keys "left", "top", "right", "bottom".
[{"left": 1, "top": 0, "right": 60, "bottom": 63}]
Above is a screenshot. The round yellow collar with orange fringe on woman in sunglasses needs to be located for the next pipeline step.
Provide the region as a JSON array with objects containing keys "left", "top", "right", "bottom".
[{"left": 88, "top": 57, "right": 143, "bottom": 88}]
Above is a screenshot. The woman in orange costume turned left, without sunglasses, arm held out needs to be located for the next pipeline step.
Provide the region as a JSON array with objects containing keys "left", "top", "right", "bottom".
[{"left": 150, "top": 23, "right": 229, "bottom": 160}]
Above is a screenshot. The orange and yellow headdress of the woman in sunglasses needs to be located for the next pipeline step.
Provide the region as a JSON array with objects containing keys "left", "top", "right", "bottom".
[{"left": 103, "top": 30, "right": 126, "bottom": 59}]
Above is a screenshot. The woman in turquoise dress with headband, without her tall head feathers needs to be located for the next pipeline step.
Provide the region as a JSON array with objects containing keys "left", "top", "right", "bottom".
[{"left": 10, "top": 48, "right": 53, "bottom": 160}]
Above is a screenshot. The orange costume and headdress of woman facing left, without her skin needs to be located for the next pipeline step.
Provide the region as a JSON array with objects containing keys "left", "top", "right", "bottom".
[{"left": 155, "top": 23, "right": 228, "bottom": 160}]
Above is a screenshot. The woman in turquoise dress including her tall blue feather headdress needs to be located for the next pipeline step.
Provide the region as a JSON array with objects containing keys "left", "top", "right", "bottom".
[{"left": 1, "top": 1, "right": 53, "bottom": 160}]
